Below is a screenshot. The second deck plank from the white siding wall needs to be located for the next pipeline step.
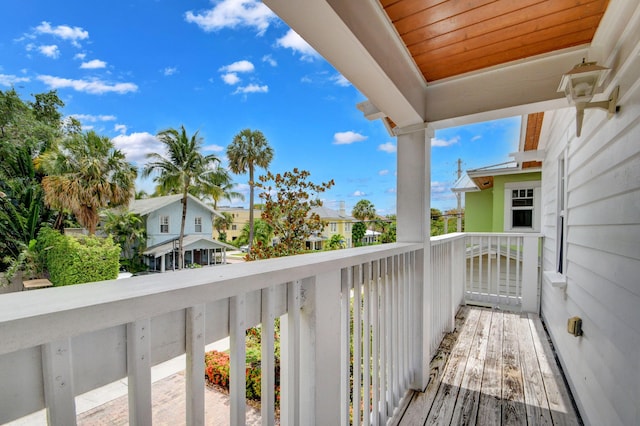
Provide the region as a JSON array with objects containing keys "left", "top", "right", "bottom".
[{"left": 516, "top": 314, "right": 552, "bottom": 425}]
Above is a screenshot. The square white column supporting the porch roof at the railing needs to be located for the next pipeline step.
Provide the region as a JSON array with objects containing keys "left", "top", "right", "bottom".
[{"left": 397, "top": 127, "right": 434, "bottom": 390}]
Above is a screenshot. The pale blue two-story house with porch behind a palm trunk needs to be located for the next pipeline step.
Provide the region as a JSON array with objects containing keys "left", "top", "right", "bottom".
[{"left": 129, "top": 194, "right": 235, "bottom": 272}]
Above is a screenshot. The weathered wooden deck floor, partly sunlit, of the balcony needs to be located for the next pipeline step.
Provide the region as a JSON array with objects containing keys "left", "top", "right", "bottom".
[{"left": 399, "top": 306, "right": 582, "bottom": 426}]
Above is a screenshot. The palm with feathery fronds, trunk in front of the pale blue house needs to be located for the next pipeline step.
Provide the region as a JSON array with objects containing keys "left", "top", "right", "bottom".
[{"left": 142, "top": 126, "right": 220, "bottom": 268}]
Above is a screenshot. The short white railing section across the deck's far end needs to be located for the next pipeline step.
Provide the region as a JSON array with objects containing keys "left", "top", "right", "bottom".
[{"left": 465, "top": 233, "right": 541, "bottom": 312}]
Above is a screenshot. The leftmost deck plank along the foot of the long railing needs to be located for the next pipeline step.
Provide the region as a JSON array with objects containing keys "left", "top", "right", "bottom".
[{"left": 398, "top": 306, "right": 469, "bottom": 426}]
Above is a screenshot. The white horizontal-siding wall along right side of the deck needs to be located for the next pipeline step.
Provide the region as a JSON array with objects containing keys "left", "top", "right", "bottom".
[{"left": 541, "top": 66, "right": 640, "bottom": 425}]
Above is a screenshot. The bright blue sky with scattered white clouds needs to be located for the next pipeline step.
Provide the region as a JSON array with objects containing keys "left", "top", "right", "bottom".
[{"left": 0, "top": 0, "right": 520, "bottom": 214}]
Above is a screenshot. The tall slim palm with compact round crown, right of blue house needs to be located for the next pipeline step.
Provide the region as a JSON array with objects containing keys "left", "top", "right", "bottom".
[{"left": 227, "top": 129, "right": 273, "bottom": 249}]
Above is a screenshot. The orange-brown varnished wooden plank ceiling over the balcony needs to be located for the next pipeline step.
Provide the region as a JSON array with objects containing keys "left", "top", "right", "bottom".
[{"left": 379, "top": 0, "right": 609, "bottom": 82}]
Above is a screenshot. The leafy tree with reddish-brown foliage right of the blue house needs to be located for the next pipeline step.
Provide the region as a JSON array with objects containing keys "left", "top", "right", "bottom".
[{"left": 248, "top": 168, "right": 334, "bottom": 260}]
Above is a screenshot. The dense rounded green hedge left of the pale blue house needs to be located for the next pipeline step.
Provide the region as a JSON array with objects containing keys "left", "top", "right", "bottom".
[{"left": 37, "top": 228, "right": 120, "bottom": 286}]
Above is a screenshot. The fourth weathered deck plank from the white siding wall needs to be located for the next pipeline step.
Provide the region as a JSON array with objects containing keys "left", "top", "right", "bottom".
[{"left": 477, "top": 311, "right": 504, "bottom": 425}]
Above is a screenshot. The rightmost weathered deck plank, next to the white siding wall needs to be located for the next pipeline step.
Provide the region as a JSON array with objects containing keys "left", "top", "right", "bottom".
[{"left": 529, "top": 314, "right": 580, "bottom": 425}]
